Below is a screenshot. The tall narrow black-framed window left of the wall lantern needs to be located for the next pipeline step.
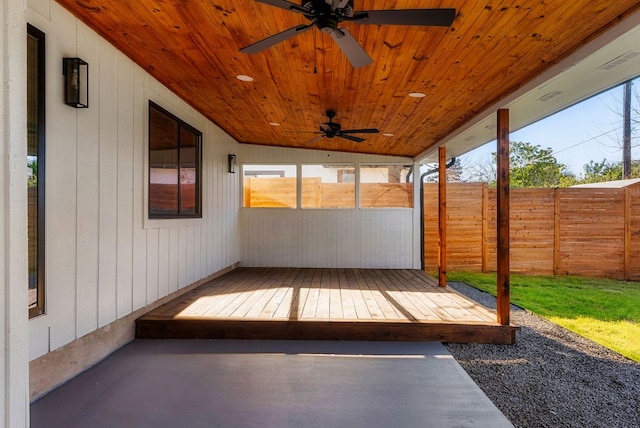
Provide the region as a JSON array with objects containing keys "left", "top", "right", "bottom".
[{"left": 27, "top": 24, "right": 45, "bottom": 318}]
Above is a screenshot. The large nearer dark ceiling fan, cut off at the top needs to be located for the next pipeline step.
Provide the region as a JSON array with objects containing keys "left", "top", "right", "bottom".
[{"left": 240, "top": 0, "right": 456, "bottom": 68}]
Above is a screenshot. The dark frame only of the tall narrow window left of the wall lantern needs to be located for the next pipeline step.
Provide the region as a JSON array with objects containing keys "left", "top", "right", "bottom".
[{"left": 27, "top": 23, "right": 46, "bottom": 318}]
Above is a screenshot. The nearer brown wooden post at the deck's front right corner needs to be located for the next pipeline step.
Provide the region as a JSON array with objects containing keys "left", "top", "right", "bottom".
[{"left": 496, "top": 109, "right": 511, "bottom": 325}]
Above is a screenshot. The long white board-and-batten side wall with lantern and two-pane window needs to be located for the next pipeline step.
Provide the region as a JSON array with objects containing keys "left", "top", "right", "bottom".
[{"left": 25, "top": 0, "right": 240, "bottom": 359}]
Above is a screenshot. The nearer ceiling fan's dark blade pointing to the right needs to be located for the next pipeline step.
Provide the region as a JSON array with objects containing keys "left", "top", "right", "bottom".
[{"left": 352, "top": 9, "right": 456, "bottom": 27}]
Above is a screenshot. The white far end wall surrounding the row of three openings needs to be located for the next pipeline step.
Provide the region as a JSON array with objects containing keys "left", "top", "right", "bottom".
[{"left": 237, "top": 146, "right": 420, "bottom": 268}]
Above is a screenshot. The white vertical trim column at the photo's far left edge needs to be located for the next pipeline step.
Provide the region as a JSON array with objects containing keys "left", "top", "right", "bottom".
[{"left": 0, "top": 0, "right": 29, "bottom": 427}]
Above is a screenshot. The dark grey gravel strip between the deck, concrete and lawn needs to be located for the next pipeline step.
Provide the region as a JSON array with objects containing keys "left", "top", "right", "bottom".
[{"left": 445, "top": 282, "right": 640, "bottom": 428}]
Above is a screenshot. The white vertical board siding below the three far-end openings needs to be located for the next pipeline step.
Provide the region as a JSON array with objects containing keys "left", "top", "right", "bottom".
[{"left": 241, "top": 208, "right": 413, "bottom": 268}]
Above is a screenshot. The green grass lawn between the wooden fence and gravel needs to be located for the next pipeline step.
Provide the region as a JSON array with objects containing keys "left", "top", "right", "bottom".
[{"left": 447, "top": 272, "right": 640, "bottom": 362}]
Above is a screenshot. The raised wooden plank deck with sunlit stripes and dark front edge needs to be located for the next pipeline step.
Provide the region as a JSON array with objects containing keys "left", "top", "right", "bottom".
[{"left": 136, "top": 268, "right": 517, "bottom": 344}]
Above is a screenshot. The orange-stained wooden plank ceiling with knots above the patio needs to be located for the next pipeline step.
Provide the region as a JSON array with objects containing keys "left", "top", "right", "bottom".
[{"left": 57, "top": 0, "right": 640, "bottom": 157}]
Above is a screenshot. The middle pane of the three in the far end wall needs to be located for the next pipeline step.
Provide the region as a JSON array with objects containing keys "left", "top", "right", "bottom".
[{"left": 302, "top": 165, "right": 356, "bottom": 208}]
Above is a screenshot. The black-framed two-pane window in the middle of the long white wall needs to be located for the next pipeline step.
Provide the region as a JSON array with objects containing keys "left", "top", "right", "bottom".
[{"left": 149, "top": 101, "right": 202, "bottom": 219}]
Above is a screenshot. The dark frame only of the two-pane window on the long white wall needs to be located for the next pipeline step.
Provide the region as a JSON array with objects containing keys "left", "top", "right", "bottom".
[{"left": 146, "top": 100, "right": 203, "bottom": 220}]
